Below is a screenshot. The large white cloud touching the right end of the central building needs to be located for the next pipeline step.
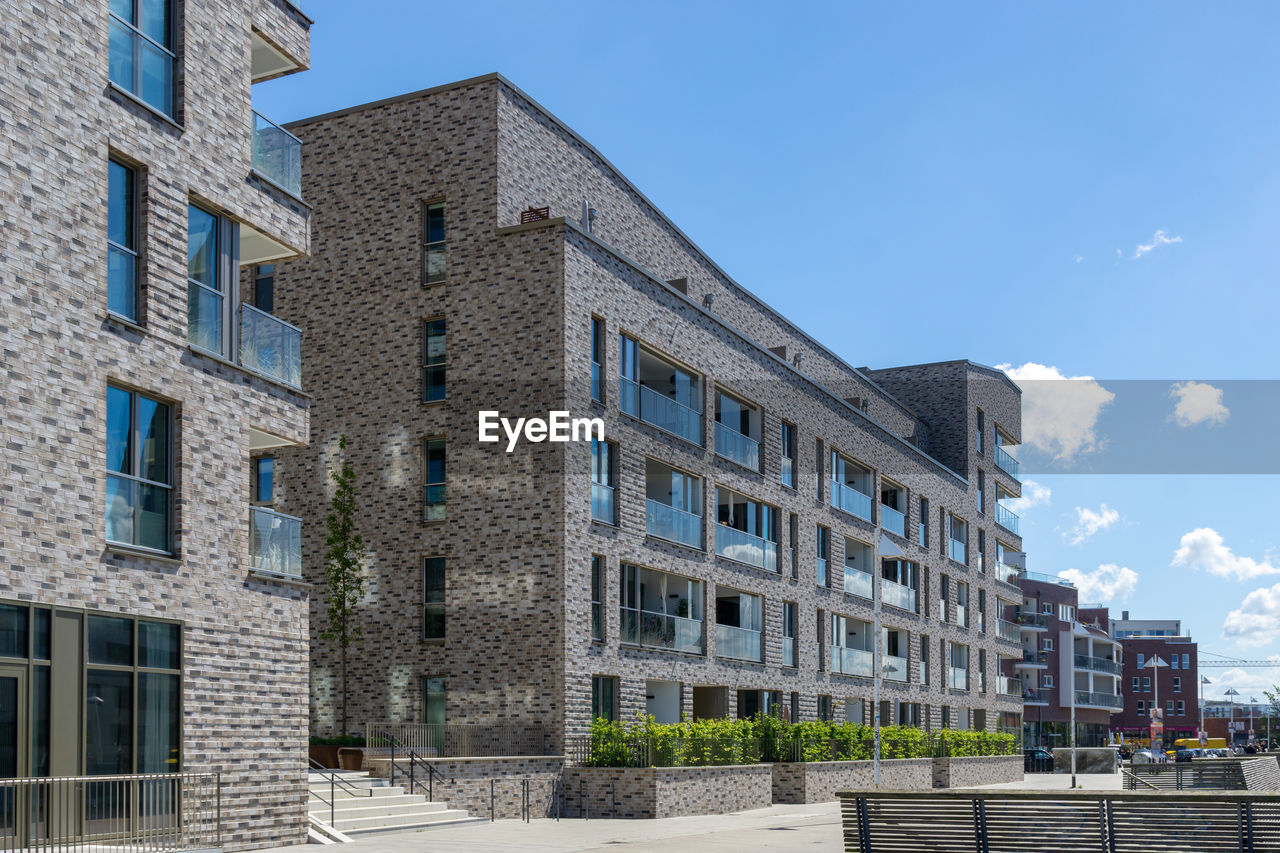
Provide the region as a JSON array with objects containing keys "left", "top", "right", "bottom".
[{"left": 997, "top": 361, "right": 1115, "bottom": 462}]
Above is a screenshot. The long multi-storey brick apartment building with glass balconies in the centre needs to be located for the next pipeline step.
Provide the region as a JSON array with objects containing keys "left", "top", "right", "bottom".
[{"left": 272, "top": 74, "right": 1021, "bottom": 751}]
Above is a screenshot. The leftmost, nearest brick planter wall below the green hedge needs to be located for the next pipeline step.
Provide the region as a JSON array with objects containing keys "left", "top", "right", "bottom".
[{"left": 563, "top": 765, "right": 773, "bottom": 818}]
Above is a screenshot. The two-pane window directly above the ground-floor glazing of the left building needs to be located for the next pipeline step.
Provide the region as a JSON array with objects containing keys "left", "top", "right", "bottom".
[{"left": 106, "top": 386, "right": 173, "bottom": 553}]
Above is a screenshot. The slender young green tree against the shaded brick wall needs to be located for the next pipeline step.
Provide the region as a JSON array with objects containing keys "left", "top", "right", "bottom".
[{"left": 320, "top": 435, "right": 365, "bottom": 734}]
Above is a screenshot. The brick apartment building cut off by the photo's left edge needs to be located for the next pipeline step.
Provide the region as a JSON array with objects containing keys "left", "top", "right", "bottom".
[{"left": 0, "top": 0, "right": 311, "bottom": 849}]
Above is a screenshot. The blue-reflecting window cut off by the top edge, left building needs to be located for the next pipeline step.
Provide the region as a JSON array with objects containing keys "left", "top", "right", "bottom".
[{"left": 108, "top": 0, "right": 175, "bottom": 115}]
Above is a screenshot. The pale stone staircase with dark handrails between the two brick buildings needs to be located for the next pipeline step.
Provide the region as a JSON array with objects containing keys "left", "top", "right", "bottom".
[{"left": 307, "top": 770, "right": 481, "bottom": 843}]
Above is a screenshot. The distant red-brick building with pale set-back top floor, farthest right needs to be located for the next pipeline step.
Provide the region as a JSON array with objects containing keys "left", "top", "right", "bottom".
[{"left": 1111, "top": 611, "right": 1201, "bottom": 744}]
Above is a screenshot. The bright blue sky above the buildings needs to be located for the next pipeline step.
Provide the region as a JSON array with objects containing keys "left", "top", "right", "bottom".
[{"left": 255, "top": 0, "right": 1280, "bottom": 698}]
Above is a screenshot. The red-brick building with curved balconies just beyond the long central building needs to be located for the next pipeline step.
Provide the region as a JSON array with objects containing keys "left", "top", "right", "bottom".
[{"left": 1010, "top": 571, "right": 1124, "bottom": 748}]
